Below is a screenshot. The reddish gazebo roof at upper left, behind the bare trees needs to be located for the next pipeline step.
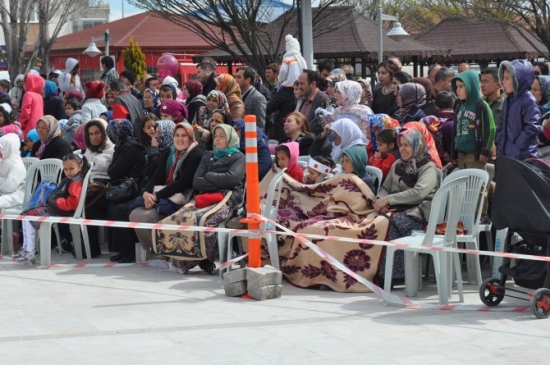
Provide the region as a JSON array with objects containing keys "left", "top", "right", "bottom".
[{"left": 52, "top": 12, "right": 220, "bottom": 53}]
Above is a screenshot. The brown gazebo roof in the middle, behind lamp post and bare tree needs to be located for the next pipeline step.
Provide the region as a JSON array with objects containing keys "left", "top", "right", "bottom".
[{"left": 194, "top": 7, "right": 448, "bottom": 62}]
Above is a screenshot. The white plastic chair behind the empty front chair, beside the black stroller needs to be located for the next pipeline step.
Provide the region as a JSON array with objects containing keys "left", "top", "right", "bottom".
[{"left": 443, "top": 169, "right": 489, "bottom": 285}]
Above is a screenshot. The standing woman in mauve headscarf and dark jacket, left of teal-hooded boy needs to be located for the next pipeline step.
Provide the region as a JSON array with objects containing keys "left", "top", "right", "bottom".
[{"left": 393, "top": 82, "right": 426, "bottom": 125}]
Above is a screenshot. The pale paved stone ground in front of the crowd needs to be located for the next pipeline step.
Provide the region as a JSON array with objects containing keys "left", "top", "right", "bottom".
[{"left": 0, "top": 249, "right": 550, "bottom": 365}]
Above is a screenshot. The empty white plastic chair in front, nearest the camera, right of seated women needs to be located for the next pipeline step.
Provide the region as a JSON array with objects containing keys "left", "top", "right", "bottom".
[{"left": 384, "top": 176, "right": 468, "bottom": 305}]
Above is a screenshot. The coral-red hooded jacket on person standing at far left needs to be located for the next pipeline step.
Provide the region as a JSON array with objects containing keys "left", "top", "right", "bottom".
[{"left": 19, "top": 74, "right": 45, "bottom": 137}]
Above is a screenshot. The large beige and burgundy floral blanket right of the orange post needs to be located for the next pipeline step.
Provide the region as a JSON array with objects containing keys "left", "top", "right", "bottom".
[{"left": 260, "top": 171, "right": 389, "bottom": 293}]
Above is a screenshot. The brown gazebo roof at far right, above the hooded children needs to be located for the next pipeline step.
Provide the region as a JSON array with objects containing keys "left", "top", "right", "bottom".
[{"left": 417, "top": 18, "right": 546, "bottom": 62}]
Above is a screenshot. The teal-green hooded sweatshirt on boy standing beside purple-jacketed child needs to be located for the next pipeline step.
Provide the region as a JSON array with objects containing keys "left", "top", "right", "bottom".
[{"left": 451, "top": 70, "right": 495, "bottom": 158}]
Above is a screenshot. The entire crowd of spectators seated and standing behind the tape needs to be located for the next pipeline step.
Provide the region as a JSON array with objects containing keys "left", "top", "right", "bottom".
[{"left": 0, "top": 36, "right": 550, "bottom": 291}]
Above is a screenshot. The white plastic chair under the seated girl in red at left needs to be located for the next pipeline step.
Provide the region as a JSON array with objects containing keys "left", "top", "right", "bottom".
[{"left": 38, "top": 166, "right": 93, "bottom": 266}]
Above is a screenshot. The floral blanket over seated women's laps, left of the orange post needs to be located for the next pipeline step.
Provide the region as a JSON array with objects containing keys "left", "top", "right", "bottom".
[{"left": 152, "top": 192, "right": 232, "bottom": 260}]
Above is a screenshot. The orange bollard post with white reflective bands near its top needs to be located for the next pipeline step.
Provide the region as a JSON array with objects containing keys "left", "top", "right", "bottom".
[{"left": 241, "top": 115, "right": 262, "bottom": 267}]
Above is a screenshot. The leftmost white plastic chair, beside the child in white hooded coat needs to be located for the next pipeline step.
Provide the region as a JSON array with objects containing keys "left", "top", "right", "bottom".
[{"left": 2, "top": 158, "right": 63, "bottom": 255}]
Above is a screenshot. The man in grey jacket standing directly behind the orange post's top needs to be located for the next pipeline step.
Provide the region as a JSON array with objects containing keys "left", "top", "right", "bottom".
[{"left": 235, "top": 67, "right": 267, "bottom": 130}]
